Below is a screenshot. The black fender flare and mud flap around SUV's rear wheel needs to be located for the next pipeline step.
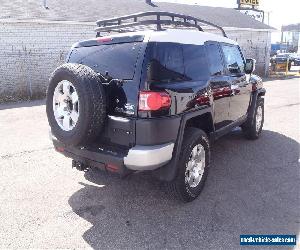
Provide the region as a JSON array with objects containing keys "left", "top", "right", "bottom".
[{"left": 153, "top": 107, "right": 213, "bottom": 182}]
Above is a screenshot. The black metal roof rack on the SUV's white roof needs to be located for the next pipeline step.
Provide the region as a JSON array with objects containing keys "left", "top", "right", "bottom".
[{"left": 95, "top": 11, "right": 227, "bottom": 37}]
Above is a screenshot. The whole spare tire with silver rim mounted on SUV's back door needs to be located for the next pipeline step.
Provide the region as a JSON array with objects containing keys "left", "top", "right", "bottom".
[{"left": 46, "top": 63, "right": 106, "bottom": 146}]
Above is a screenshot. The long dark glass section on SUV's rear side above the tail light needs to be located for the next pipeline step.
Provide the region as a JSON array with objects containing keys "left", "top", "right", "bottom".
[{"left": 147, "top": 42, "right": 208, "bottom": 82}]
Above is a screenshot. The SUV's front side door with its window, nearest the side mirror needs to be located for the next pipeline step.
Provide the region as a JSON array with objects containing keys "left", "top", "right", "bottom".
[{"left": 221, "top": 44, "right": 251, "bottom": 122}]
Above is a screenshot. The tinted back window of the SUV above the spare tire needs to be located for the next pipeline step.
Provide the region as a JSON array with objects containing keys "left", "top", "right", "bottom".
[{"left": 69, "top": 42, "right": 142, "bottom": 79}]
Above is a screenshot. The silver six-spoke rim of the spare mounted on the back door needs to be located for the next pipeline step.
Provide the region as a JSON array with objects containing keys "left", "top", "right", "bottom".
[{"left": 53, "top": 80, "right": 79, "bottom": 131}]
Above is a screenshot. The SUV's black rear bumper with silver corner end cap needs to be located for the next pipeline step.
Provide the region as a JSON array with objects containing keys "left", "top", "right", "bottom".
[{"left": 52, "top": 137, "right": 174, "bottom": 175}]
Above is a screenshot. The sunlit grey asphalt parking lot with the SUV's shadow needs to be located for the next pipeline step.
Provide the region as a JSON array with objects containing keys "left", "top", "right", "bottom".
[{"left": 0, "top": 78, "right": 300, "bottom": 250}]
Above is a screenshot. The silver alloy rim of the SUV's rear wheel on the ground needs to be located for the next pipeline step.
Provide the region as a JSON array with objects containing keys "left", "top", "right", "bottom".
[{"left": 185, "top": 144, "right": 205, "bottom": 188}]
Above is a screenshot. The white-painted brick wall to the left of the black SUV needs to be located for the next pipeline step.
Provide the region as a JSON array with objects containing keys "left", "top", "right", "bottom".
[{"left": 0, "top": 21, "right": 96, "bottom": 102}]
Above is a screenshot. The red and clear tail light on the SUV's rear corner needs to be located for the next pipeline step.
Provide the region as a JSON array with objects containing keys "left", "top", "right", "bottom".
[{"left": 139, "top": 91, "right": 171, "bottom": 111}]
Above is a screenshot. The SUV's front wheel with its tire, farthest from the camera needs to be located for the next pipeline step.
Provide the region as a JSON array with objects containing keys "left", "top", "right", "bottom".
[{"left": 241, "top": 97, "right": 264, "bottom": 140}]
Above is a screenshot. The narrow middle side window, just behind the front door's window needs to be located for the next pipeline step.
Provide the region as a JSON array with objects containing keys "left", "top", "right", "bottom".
[{"left": 206, "top": 44, "right": 224, "bottom": 76}]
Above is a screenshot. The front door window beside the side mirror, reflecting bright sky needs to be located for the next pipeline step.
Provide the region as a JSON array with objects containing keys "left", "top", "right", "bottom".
[{"left": 222, "top": 45, "right": 245, "bottom": 73}]
